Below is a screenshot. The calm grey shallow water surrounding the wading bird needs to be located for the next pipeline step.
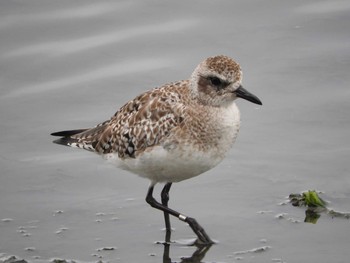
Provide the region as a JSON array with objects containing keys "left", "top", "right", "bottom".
[{"left": 0, "top": 0, "right": 350, "bottom": 263}]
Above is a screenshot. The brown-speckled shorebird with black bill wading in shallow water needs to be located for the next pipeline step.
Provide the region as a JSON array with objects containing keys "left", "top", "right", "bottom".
[{"left": 51, "top": 55, "right": 262, "bottom": 245}]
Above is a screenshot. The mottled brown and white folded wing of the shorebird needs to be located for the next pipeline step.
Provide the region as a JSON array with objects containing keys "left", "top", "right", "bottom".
[{"left": 71, "top": 89, "right": 185, "bottom": 158}]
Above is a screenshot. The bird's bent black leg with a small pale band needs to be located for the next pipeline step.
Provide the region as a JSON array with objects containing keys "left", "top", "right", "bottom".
[{"left": 146, "top": 185, "right": 214, "bottom": 244}]
